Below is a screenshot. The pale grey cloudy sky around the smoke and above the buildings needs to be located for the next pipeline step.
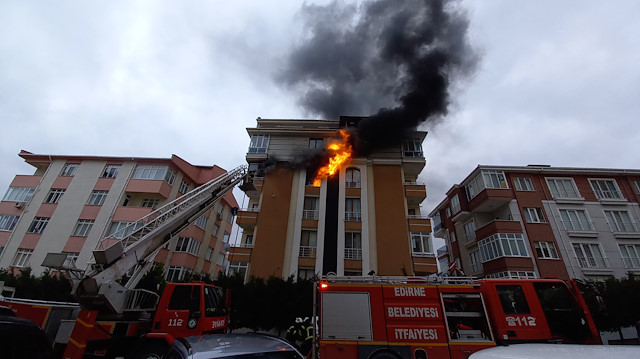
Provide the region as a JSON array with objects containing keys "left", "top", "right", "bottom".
[{"left": 0, "top": 0, "right": 640, "bottom": 248}]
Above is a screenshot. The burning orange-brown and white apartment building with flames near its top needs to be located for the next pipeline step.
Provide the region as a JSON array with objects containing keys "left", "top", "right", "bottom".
[{"left": 229, "top": 117, "right": 437, "bottom": 278}]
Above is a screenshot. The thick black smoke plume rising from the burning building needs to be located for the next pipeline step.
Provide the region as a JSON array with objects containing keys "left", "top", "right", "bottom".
[{"left": 278, "top": 0, "right": 478, "bottom": 155}]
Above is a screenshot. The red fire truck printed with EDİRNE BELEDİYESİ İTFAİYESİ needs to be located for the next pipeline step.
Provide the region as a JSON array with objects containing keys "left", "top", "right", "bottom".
[{"left": 313, "top": 276, "right": 601, "bottom": 359}]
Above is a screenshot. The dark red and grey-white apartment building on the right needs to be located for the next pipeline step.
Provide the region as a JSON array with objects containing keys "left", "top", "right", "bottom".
[{"left": 430, "top": 165, "right": 640, "bottom": 280}]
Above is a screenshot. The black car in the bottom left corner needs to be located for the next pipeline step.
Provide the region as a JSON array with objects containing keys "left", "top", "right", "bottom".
[{"left": 0, "top": 312, "right": 53, "bottom": 359}]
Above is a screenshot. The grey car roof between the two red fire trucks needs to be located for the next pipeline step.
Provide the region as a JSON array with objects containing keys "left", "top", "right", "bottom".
[{"left": 163, "top": 333, "right": 304, "bottom": 359}]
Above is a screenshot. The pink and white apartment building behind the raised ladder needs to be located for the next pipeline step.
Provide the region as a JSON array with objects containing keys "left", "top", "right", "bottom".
[{"left": 0, "top": 151, "right": 237, "bottom": 280}]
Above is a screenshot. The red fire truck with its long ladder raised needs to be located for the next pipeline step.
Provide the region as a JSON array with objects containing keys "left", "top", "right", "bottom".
[{"left": 0, "top": 166, "right": 252, "bottom": 359}]
